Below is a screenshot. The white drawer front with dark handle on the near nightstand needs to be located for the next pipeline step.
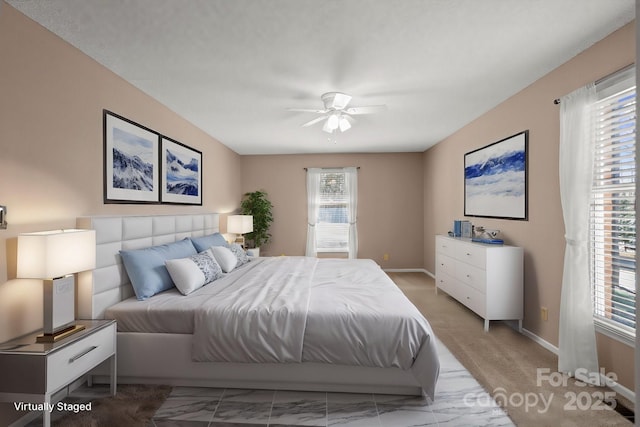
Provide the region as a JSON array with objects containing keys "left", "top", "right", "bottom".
[{"left": 46, "top": 324, "right": 116, "bottom": 393}]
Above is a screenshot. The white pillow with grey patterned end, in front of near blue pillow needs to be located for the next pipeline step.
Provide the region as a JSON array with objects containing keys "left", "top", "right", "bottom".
[{"left": 165, "top": 250, "right": 222, "bottom": 295}]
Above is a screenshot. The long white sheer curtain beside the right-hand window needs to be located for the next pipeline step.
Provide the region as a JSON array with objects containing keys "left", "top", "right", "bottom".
[{"left": 558, "top": 84, "right": 599, "bottom": 383}]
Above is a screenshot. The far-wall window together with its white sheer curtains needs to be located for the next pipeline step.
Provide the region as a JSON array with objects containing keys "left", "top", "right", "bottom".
[{"left": 306, "top": 167, "right": 358, "bottom": 258}]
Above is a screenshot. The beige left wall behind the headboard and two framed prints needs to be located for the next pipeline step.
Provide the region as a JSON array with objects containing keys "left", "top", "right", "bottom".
[{"left": 0, "top": 1, "right": 241, "bottom": 342}]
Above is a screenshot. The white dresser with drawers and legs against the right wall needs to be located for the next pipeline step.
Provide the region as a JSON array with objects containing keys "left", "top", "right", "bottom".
[{"left": 436, "top": 236, "right": 524, "bottom": 331}]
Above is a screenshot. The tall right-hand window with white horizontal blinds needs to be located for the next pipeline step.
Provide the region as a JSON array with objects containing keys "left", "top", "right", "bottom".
[{"left": 590, "top": 67, "right": 636, "bottom": 343}]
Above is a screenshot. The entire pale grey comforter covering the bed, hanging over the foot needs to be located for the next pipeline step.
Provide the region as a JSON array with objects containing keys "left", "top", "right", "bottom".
[{"left": 193, "top": 257, "right": 439, "bottom": 396}]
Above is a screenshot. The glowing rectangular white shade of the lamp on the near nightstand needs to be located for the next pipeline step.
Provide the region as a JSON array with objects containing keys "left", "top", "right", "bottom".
[{"left": 17, "top": 229, "right": 96, "bottom": 279}]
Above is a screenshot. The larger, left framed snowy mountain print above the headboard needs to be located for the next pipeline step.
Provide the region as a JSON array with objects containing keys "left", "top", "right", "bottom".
[{"left": 103, "top": 110, "right": 160, "bottom": 203}]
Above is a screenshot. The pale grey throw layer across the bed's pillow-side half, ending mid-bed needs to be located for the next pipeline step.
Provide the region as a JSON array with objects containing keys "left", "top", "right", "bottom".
[{"left": 193, "top": 257, "right": 317, "bottom": 363}]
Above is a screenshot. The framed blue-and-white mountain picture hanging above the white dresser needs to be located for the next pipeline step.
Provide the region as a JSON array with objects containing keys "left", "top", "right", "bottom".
[{"left": 464, "top": 130, "right": 529, "bottom": 221}]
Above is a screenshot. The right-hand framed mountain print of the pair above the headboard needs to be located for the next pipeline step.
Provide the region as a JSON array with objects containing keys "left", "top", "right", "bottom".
[{"left": 160, "top": 136, "right": 202, "bottom": 205}]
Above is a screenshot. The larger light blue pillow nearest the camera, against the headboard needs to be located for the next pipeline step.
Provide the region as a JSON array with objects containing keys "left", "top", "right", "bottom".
[{"left": 120, "top": 239, "right": 198, "bottom": 301}]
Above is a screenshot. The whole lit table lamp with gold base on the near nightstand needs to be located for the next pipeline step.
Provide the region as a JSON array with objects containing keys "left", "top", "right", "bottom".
[{"left": 17, "top": 229, "right": 96, "bottom": 342}]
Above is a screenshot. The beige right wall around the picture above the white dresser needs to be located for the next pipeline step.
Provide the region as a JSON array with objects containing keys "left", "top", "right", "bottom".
[{"left": 424, "top": 23, "right": 636, "bottom": 390}]
